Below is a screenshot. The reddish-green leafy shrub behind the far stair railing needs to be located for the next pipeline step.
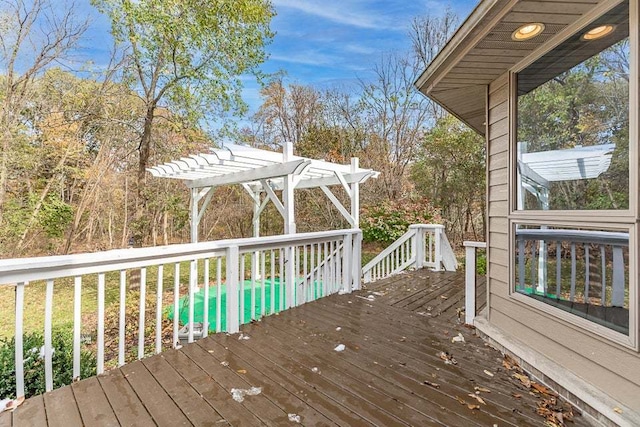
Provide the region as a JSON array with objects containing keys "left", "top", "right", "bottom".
[{"left": 360, "top": 198, "right": 440, "bottom": 244}]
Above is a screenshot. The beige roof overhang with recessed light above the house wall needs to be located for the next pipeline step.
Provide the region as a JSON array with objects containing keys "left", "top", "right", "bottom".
[{"left": 415, "top": 0, "right": 605, "bottom": 135}]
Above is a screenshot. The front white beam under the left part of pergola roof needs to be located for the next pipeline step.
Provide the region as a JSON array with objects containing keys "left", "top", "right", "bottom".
[{"left": 185, "top": 160, "right": 311, "bottom": 188}]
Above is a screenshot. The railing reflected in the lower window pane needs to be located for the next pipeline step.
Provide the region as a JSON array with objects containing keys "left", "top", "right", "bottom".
[{"left": 516, "top": 229, "right": 629, "bottom": 307}]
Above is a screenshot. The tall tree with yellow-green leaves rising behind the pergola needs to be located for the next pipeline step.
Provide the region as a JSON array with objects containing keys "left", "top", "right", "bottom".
[{"left": 92, "top": 0, "right": 274, "bottom": 244}]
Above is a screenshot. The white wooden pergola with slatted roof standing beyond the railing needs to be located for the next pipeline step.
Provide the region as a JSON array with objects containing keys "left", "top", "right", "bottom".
[{"left": 147, "top": 143, "right": 379, "bottom": 243}]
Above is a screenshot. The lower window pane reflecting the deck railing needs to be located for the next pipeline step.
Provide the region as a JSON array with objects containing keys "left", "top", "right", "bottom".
[{"left": 515, "top": 224, "right": 629, "bottom": 335}]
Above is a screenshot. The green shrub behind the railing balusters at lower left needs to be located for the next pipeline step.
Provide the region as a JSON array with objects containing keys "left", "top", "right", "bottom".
[{"left": 0, "top": 330, "right": 96, "bottom": 399}]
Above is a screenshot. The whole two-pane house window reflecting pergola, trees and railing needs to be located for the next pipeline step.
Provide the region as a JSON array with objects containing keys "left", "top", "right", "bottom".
[{"left": 511, "top": 1, "right": 637, "bottom": 343}]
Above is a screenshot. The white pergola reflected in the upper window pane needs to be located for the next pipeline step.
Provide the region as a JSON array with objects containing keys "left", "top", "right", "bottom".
[{"left": 518, "top": 142, "right": 616, "bottom": 210}]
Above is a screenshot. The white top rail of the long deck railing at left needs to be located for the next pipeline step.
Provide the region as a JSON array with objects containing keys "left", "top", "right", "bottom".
[{"left": 0, "top": 229, "right": 360, "bottom": 285}]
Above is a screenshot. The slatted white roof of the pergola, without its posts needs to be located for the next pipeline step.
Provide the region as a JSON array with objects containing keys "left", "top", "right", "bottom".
[{"left": 147, "top": 144, "right": 379, "bottom": 190}]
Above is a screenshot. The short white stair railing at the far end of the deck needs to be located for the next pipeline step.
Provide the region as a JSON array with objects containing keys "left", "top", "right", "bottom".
[{"left": 362, "top": 224, "right": 458, "bottom": 283}]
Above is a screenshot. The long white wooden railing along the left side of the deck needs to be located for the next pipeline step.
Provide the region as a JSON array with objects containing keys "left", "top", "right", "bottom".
[{"left": 0, "top": 229, "right": 362, "bottom": 397}]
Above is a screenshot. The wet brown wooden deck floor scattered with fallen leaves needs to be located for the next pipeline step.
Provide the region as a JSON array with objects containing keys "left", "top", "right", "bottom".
[{"left": 0, "top": 270, "right": 585, "bottom": 427}]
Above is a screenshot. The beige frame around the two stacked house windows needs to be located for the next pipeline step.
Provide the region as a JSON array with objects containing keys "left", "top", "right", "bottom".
[{"left": 507, "top": 0, "right": 640, "bottom": 352}]
